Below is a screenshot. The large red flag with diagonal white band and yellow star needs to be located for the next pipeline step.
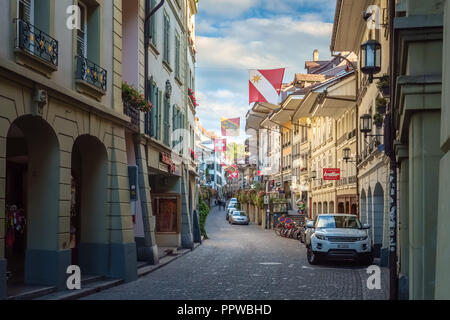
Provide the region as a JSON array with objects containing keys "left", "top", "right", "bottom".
[{"left": 249, "top": 68, "right": 285, "bottom": 104}]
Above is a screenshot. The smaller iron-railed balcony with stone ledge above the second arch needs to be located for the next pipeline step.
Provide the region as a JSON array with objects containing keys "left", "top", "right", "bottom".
[{"left": 75, "top": 56, "right": 108, "bottom": 101}]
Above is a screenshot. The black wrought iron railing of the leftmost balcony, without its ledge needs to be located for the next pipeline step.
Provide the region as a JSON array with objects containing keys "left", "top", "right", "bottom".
[{"left": 15, "top": 19, "right": 58, "bottom": 67}]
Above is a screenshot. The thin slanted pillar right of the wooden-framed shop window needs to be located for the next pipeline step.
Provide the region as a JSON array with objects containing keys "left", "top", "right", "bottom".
[{"left": 181, "top": 165, "right": 194, "bottom": 250}]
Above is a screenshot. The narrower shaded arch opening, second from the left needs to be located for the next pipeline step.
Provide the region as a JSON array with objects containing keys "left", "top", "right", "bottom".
[{"left": 70, "top": 135, "right": 109, "bottom": 275}]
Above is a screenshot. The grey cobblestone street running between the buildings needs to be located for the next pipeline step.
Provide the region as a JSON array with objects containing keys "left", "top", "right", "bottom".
[{"left": 85, "top": 208, "right": 389, "bottom": 300}]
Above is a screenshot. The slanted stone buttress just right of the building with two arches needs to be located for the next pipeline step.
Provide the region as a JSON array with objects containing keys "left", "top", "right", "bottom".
[{"left": 134, "top": 136, "right": 159, "bottom": 264}]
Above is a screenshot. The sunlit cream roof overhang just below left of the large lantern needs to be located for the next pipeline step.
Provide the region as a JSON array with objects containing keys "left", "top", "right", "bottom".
[{"left": 312, "top": 75, "right": 356, "bottom": 119}]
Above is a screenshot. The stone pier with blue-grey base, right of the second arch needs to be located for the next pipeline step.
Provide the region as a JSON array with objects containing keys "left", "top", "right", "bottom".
[{"left": 107, "top": 128, "right": 137, "bottom": 282}]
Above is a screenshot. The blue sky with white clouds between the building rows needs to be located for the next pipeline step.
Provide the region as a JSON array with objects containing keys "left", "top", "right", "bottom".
[{"left": 195, "top": 0, "right": 336, "bottom": 142}]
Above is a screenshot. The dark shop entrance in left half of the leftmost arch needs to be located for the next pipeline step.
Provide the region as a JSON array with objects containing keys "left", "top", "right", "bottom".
[{"left": 5, "top": 124, "right": 28, "bottom": 284}]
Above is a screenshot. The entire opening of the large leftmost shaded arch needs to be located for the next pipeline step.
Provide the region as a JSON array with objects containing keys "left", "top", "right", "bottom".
[{"left": 0, "top": 115, "right": 60, "bottom": 287}]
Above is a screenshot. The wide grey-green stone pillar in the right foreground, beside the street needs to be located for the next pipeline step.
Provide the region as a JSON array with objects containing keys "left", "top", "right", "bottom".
[{"left": 409, "top": 111, "right": 442, "bottom": 300}]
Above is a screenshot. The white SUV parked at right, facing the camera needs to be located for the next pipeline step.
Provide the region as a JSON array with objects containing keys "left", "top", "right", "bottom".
[{"left": 305, "top": 214, "right": 373, "bottom": 265}]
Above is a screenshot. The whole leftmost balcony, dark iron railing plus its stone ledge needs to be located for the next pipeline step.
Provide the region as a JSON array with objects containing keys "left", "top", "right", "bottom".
[{"left": 15, "top": 19, "right": 58, "bottom": 77}]
